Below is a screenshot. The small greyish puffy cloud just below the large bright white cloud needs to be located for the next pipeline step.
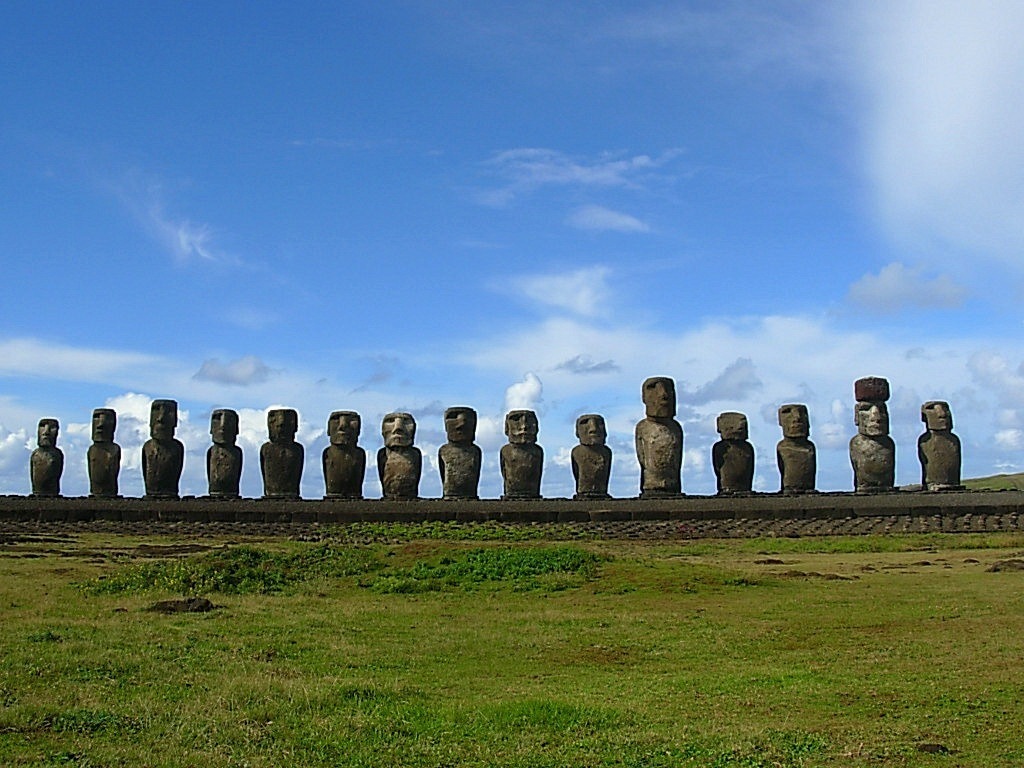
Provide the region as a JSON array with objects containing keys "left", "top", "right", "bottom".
[{"left": 848, "top": 262, "right": 967, "bottom": 312}]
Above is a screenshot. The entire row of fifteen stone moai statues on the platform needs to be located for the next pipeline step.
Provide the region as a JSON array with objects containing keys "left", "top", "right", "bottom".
[{"left": 31, "top": 377, "right": 962, "bottom": 500}]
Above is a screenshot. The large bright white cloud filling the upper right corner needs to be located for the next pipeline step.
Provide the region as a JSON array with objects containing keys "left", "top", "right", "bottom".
[{"left": 846, "top": 0, "right": 1024, "bottom": 267}]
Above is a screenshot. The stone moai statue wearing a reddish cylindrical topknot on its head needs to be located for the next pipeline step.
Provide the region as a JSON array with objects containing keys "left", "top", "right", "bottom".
[{"left": 850, "top": 376, "right": 896, "bottom": 494}]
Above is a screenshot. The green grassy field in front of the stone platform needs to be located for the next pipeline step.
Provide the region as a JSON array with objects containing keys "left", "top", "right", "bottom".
[{"left": 0, "top": 526, "right": 1024, "bottom": 767}]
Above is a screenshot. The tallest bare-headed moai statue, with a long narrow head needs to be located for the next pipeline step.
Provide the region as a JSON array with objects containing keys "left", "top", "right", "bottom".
[{"left": 636, "top": 376, "right": 683, "bottom": 499}]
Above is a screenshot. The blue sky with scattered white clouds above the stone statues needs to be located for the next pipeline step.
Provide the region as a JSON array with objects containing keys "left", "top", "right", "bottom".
[{"left": 0, "top": 0, "right": 1024, "bottom": 498}]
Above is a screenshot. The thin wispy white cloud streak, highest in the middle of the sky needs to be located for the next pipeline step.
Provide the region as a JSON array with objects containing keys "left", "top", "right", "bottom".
[{"left": 480, "top": 147, "right": 680, "bottom": 206}]
